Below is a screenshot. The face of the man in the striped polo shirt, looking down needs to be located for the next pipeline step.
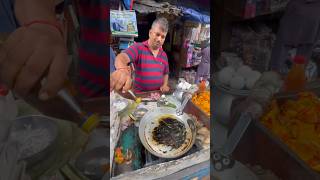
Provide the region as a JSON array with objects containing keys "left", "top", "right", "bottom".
[{"left": 149, "top": 24, "right": 167, "bottom": 49}]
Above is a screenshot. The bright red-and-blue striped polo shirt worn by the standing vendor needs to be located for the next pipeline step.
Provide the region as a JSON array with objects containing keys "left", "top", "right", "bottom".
[{"left": 124, "top": 41, "right": 169, "bottom": 92}]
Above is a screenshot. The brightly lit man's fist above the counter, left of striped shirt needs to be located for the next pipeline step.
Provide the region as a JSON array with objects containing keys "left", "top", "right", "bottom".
[{"left": 110, "top": 69, "right": 132, "bottom": 92}]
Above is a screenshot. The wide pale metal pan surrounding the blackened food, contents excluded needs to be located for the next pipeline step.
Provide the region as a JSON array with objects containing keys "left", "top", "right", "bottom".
[{"left": 139, "top": 107, "right": 196, "bottom": 158}]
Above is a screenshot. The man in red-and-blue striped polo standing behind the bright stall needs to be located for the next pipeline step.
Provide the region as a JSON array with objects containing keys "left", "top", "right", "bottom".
[{"left": 110, "top": 18, "right": 170, "bottom": 92}]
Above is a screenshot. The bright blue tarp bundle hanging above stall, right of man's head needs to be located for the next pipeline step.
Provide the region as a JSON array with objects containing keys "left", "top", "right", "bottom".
[{"left": 179, "top": 7, "right": 210, "bottom": 24}]
